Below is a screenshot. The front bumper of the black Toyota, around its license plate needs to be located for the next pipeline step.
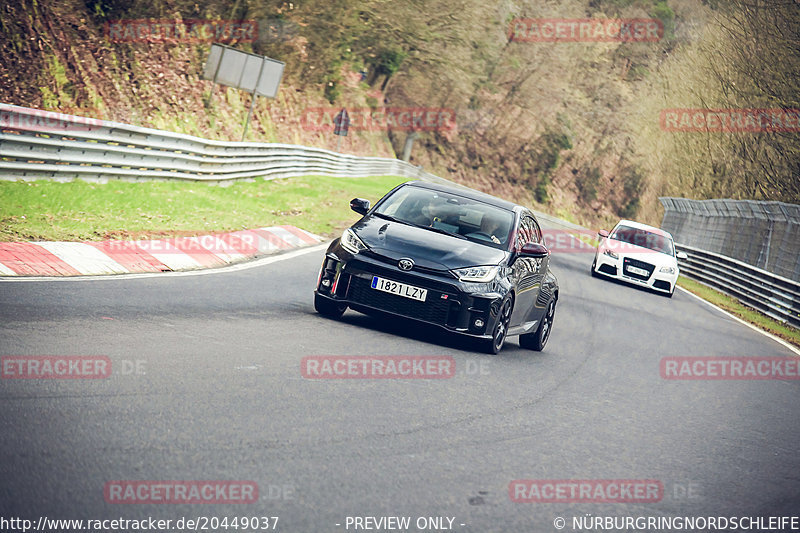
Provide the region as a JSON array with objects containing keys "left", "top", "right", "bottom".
[{"left": 315, "top": 249, "right": 505, "bottom": 339}]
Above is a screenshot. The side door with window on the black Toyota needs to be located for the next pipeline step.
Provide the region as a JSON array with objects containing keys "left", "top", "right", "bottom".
[{"left": 511, "top": 212, "right": 548, "bottom": 330}]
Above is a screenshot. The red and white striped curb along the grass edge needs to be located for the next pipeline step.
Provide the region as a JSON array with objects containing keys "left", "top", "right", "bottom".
[{"left": 0, "top": 226, "right": 322, "bottom": 276}]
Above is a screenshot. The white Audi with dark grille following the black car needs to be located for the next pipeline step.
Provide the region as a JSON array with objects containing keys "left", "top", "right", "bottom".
[{"left": 592, "top": 220, "right": 687, "bottom": 298}]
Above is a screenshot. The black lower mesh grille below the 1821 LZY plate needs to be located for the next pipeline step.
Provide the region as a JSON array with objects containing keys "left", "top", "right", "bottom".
[{"left": 347, "top": 276, "right": 458, "bottom": 325}]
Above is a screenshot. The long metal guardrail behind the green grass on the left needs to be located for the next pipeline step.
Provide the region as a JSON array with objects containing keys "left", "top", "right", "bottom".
[{"left": 0, "top": 104, "right": 445, "bottom": 183}]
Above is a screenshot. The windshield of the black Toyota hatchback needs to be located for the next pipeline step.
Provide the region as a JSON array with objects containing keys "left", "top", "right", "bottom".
[{"left": 375, "top": 186, "right": 514, "bottom": 249}]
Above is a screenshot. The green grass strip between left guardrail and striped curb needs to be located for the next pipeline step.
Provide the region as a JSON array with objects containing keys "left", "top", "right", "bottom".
[{"left": 0, "top": 176, "right": 407, "bottom": 241}]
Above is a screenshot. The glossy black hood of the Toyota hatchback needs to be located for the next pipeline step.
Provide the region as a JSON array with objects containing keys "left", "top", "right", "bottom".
[{"left": 352, "top": 217, "right": 508, "bottom": 270}]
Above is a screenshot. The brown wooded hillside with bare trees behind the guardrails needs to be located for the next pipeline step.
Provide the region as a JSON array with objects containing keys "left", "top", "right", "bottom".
[{"left": 0, "top": 0, "right": 800, "bottom": 225}]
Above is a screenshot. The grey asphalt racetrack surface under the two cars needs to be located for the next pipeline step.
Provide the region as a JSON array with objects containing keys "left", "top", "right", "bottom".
[{"left": 0, "top": 237, "right": 800, "bottom": 533}]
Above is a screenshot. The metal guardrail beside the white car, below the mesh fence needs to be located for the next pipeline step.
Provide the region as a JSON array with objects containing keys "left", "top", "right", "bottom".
[{"left": 675, "top": 243, "right": 800, "bottom": 328}]
